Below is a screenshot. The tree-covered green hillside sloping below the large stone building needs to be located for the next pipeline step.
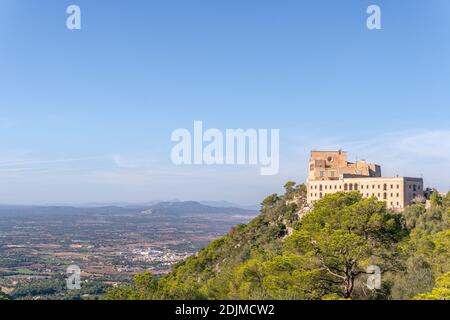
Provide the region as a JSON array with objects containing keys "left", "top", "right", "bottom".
[{"left": 104, "top": 182, "right": 450, "bottom": 300}]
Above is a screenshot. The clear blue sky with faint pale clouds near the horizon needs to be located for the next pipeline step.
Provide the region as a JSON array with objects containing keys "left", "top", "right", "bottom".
[{"left": 0, "top": 0, "right": 450, "bottom": 204}]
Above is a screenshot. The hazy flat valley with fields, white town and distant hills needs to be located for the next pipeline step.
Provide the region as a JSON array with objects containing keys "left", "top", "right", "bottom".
[{"left": 0, "top": 201, "right": 256, "bottom": 299}]
